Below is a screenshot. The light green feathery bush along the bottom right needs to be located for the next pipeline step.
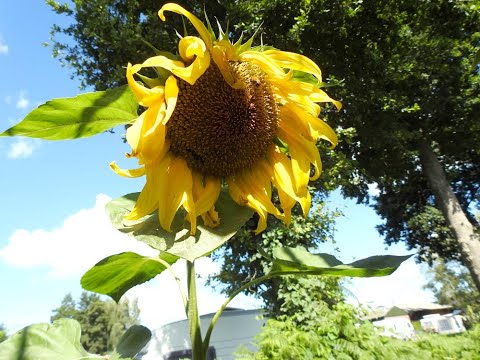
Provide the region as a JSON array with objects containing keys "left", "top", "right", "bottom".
[{"left": 236, "top": 320, "right": 480, "bottom": 360}]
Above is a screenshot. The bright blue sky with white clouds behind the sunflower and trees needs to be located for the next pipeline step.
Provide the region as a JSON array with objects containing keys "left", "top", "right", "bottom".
[{"left": 0, "top": 0, "right": 430, "bottom": 332}]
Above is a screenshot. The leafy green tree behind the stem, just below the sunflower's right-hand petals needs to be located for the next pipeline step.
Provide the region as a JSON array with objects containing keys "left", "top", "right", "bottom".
[{"left": 209, "top": 204, "right": 342, "bottom": 316}]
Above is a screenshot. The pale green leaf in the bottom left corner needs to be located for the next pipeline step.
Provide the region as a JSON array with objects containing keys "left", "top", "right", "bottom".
[{"left": 0, "top": 319, "right": 106, "bottom": 360}]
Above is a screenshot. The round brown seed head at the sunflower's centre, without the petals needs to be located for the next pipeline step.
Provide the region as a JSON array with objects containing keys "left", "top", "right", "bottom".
[{"left": 167, "top": 61, "right": 279, "bottom": 177}]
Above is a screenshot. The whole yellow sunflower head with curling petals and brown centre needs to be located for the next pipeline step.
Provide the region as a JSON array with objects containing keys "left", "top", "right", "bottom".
[{"left": 110, "top": 3, "right": 341, "bottom": 234}]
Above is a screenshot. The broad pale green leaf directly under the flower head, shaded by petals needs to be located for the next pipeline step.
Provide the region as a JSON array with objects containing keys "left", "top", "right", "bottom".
[{"left": 106, "top": 191, "right": 253, "bottom": 261}]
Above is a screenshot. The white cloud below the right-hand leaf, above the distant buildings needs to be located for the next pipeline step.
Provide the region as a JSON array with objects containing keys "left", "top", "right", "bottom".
[{"left": 349, "top": 258, "right": 434, "bottom": 307}]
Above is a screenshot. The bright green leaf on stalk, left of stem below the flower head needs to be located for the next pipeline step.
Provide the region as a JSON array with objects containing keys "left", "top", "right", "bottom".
[{"left": 81, "top": 252, "right": 178, "bottom": 302}]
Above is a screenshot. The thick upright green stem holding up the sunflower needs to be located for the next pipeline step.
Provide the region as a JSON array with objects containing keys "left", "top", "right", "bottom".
[{"left": 187, "top": 261, "right": 205, "bottom": 360}]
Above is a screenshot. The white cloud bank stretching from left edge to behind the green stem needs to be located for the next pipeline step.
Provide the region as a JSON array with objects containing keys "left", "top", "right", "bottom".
[{"left": 0, "top": 194, "right": 260, "bottom": 329}]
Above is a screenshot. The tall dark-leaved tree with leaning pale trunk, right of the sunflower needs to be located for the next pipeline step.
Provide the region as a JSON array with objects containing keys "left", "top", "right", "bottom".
[{"left": 227, "top": 0, "right": 480, "bottom": 289}]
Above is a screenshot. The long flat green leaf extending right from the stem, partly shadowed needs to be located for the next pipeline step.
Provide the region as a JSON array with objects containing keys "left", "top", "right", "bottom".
[{"left": 270, "top": 246, "right": 411, "bottom": 277}]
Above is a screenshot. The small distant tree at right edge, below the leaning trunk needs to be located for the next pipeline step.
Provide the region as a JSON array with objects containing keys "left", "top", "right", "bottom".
[{"left": 425, "top": 260, "right": 480, "bottom": 326}]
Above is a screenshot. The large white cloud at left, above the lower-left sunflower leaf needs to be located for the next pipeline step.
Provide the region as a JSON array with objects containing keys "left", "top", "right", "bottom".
[{"left": 0, "top": 194, "right": 157, "bottom": 278}]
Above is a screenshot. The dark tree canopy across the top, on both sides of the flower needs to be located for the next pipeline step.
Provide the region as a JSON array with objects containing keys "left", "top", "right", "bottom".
[{"left": 49, "top": 0, "right": 480, "bottom": 288}]
